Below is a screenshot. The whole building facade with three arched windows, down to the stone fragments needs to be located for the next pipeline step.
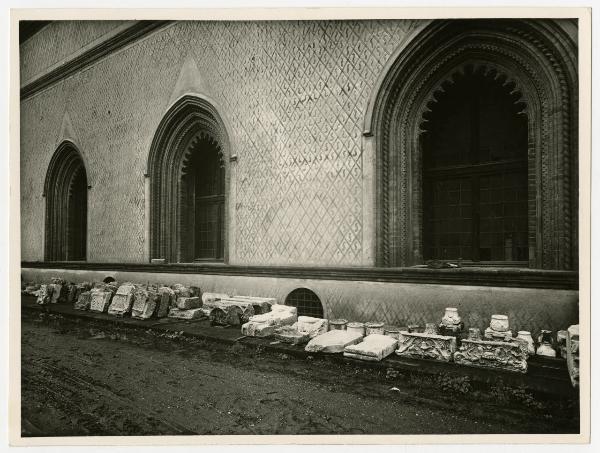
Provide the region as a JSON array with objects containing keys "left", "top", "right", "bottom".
[{"left": 20, "top": 19, "right": 578, "bottom": 331}]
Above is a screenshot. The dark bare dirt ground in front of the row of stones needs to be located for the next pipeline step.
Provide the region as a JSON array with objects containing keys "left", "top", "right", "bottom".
[{"left": 22, "top": 314, "right": 579, "bottom": 436}]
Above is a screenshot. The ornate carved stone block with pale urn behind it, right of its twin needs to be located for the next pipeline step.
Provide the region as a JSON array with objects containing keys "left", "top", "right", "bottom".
[{"left": 454, "top": 340, "right": 528, "bottom": 373}]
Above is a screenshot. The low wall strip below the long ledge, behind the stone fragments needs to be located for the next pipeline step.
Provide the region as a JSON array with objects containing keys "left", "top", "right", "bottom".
[{"left": 21, "top": 268, "right": 579, "bottom": 336}]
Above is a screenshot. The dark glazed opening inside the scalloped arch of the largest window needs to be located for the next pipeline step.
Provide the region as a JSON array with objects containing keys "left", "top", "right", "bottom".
[{"left": 421, "top": 66, "right": 528, "bottom": 265}]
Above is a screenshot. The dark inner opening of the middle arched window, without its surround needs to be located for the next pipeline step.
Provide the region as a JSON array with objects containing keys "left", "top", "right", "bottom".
[{"left": 181, "top": 134, "right": 225, "bottom": 261}]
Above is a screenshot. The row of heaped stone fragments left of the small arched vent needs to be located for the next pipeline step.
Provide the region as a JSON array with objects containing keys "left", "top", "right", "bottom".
[{"left": 23, "top": 278, "right": 275, "bottom": 327}]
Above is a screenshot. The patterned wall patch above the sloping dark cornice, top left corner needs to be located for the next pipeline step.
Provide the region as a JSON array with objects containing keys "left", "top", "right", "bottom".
[{"left": 20, "top": 20, "right": 128, "bottom": 82}]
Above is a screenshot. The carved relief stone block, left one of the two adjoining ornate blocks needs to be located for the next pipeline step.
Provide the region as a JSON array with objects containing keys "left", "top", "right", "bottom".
[{"left": 396, "top": 331, "right": 456, "bottom": 362}]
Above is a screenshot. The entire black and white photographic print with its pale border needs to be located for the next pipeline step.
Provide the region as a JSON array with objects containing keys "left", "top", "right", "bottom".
[{"left": 11, "top": 4, "right": 591, "bottom": 444}]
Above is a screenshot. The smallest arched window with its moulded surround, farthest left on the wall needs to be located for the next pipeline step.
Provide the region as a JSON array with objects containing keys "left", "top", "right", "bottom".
[{"left": 44, "top": 142, "right": 88, "bottom": 261}]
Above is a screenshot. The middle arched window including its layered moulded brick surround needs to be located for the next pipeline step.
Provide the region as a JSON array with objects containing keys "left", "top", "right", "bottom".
[{"left": 148, "top": 95, "right": 229, "bottom": 263}]
